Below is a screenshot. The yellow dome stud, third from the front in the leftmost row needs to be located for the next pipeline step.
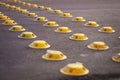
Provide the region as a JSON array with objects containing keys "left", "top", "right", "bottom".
[{"left": 29, "top": 40, "right": 50, "bottom": 49}]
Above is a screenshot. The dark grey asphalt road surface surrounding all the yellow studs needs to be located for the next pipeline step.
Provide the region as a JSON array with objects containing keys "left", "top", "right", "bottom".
[{"left": 0, "top": 0, "right": 120, "bottom": 80}]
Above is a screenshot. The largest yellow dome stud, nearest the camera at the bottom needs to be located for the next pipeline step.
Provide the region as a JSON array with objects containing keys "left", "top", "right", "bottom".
[{"left": 60, "top": 62, "right": 89, "bottom": 76}]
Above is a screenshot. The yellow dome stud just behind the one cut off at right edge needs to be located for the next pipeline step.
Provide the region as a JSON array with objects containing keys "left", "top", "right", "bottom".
[{"left": 87, "top": 41, "right": 109, "bottom": 50}]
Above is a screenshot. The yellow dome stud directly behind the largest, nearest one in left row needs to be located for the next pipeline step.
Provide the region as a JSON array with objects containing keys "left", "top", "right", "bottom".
[{"left": 42, "top": 50, "right": 67, "bottom": 61}]
